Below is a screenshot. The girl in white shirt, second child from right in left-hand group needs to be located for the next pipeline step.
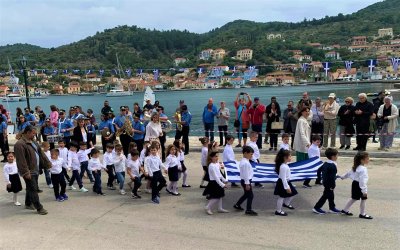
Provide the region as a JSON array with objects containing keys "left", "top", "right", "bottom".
[{"left": 164, "top": 145, "right": 182, "bottom": 196}]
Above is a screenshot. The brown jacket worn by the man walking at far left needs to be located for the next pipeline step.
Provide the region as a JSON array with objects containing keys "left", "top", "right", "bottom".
[{"left": 14, "top": 135, "right": 51, "bottom": 176}]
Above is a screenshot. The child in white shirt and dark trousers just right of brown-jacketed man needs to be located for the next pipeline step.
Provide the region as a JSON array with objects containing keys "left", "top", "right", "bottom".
[{"left": 49, "top": 149, "right": 68, "bottom": 202}]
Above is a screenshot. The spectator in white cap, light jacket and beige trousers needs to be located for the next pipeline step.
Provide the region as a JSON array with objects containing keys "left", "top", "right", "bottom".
[{"left": 322, "top": 93, "right": 340, "bottom": 148}]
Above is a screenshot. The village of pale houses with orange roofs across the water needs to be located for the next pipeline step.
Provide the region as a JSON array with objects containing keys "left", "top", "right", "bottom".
[{"left": 0, "top": 28, "right": 400, "bottom": 96}]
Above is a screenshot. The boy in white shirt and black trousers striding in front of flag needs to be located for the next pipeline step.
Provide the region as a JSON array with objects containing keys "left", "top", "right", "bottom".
[{"left": 233, "top": 146, "right": 257, "bottom": 216}]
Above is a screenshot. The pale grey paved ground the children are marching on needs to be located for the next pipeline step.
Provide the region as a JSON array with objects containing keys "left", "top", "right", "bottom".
[{"left": 0, "top": 148, "right": 400, "bottom": 249}]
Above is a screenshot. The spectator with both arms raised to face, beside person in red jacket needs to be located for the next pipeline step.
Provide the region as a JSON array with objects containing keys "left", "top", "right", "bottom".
[{"left": 234, "top": 93, "right": 251, "bottom": 148}]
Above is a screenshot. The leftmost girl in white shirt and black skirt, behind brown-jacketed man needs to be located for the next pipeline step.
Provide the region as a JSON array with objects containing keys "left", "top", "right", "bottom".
[{"left": 3, "top": 152, "right": 22, "bottom": 206}]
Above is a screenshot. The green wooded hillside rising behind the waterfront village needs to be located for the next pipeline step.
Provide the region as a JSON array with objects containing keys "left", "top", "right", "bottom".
[{"left": 0, "top": 0, "right": 400, "bottom": 70}]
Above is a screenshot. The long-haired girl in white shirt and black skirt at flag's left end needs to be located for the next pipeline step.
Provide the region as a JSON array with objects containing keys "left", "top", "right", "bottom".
[{"left": 203, "top": 151, "right": 229, "bottom": 215}]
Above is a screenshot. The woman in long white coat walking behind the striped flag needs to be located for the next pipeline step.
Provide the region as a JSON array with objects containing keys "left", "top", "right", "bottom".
[{"left": 293, "top": 107, "right": 311, "bottom": 161}]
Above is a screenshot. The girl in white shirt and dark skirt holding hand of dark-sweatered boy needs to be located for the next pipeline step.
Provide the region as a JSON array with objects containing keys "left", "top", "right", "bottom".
[{"left": 341, "top": 152, "right": 372, "bottom": 219}]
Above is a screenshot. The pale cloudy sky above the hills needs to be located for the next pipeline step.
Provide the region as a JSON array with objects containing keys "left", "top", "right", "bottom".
[{"left": 0, "top": 0, "right": 379, "bottom": 48}]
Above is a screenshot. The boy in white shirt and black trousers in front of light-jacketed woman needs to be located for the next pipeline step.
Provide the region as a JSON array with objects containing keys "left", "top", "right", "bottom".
[{"left": 144, "top": 144, "right": 167, "bottom": 204}]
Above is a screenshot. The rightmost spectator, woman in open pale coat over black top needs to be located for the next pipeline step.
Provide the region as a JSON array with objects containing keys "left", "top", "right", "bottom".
[{"left": 377, "top": 96, "right": 399, "bottom": 151}]
